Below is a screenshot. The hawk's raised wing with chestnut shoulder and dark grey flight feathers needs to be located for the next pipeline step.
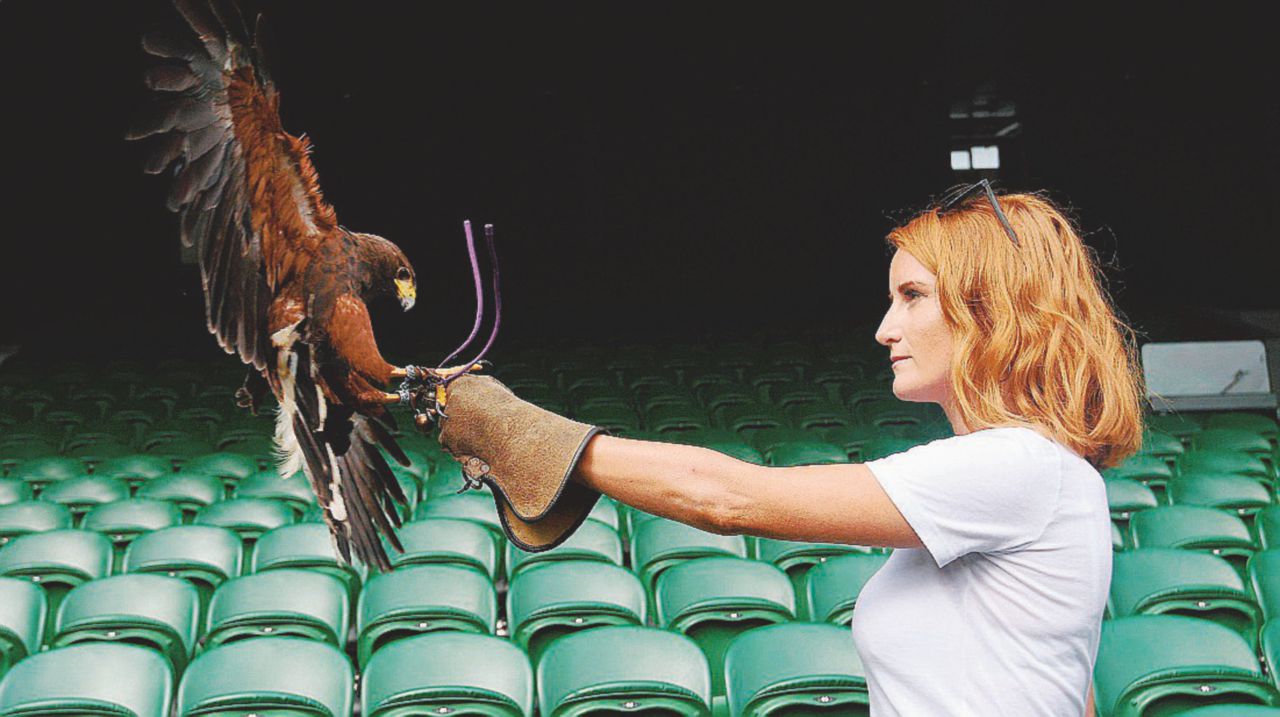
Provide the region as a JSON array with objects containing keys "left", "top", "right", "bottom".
[{"left": 127, "top": 0, "right": 338, "bottom": 370}]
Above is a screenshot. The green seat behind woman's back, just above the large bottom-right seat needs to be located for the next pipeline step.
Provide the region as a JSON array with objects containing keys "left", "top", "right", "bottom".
[{"left": 1107, "top": 548, "right": 1262, "bottom": 647}]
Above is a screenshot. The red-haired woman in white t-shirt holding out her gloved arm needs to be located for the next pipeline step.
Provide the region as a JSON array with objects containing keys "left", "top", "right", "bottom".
[{"left": 430, "top": 184, "right": 1142, "bottom": 717}]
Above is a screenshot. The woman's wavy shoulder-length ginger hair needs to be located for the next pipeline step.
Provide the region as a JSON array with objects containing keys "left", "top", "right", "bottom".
[{"left": 887, "top": 195, "right": 1143, "bottom": 469}]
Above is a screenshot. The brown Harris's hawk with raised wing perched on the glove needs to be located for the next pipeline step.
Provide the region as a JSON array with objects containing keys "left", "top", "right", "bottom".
[{"left": 128, "top": 0, "right": 416, "bottom": 570}]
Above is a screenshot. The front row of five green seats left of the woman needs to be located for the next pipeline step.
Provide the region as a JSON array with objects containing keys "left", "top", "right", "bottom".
[{"left": 0, "top": 622, "right": 869, "bottom": 717}]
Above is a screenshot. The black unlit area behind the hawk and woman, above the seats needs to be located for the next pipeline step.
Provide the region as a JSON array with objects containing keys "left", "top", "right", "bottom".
[{"left": 0, "top": 0, "right": 1280, "bottom": 362}]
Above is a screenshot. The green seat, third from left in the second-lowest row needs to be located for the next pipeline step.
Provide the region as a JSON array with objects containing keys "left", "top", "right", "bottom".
[{"left": 204, "top": 570, "right": 351, "bottom": 649}]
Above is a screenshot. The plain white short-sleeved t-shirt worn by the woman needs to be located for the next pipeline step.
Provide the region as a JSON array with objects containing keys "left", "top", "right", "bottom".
[{"left": 852, "top": 428, "right": 1111, "bottom": 717}]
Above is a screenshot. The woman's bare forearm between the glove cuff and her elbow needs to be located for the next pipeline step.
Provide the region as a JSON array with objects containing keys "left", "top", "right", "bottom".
[{"left": 573, "top": 435, "right": 762, "bottom": 534}]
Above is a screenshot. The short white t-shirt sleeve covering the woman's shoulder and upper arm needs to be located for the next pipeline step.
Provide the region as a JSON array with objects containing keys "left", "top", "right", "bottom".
[{"left": 867, "top": 428, "right": 1062, "bottom": 567}]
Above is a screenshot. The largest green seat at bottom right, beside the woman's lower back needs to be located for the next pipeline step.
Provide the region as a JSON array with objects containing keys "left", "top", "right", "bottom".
[{"left": 1093, "top": 617, "right": 1277, "bottom": 717}]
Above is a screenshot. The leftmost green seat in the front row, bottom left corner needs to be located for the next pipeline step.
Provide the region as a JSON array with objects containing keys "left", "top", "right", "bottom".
[{"left": 0, "top": 643, "right": 173, "bottom": 717}]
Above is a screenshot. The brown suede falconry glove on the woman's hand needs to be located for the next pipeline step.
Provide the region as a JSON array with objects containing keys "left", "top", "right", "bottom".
[{"left": 440, "top": 374, "right": 602, "bottom": 553}]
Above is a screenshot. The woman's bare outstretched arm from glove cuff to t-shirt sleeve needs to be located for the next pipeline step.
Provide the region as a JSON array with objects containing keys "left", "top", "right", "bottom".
[{"left": 573, "top": 435, "right": 922, "bottom": 548}]
